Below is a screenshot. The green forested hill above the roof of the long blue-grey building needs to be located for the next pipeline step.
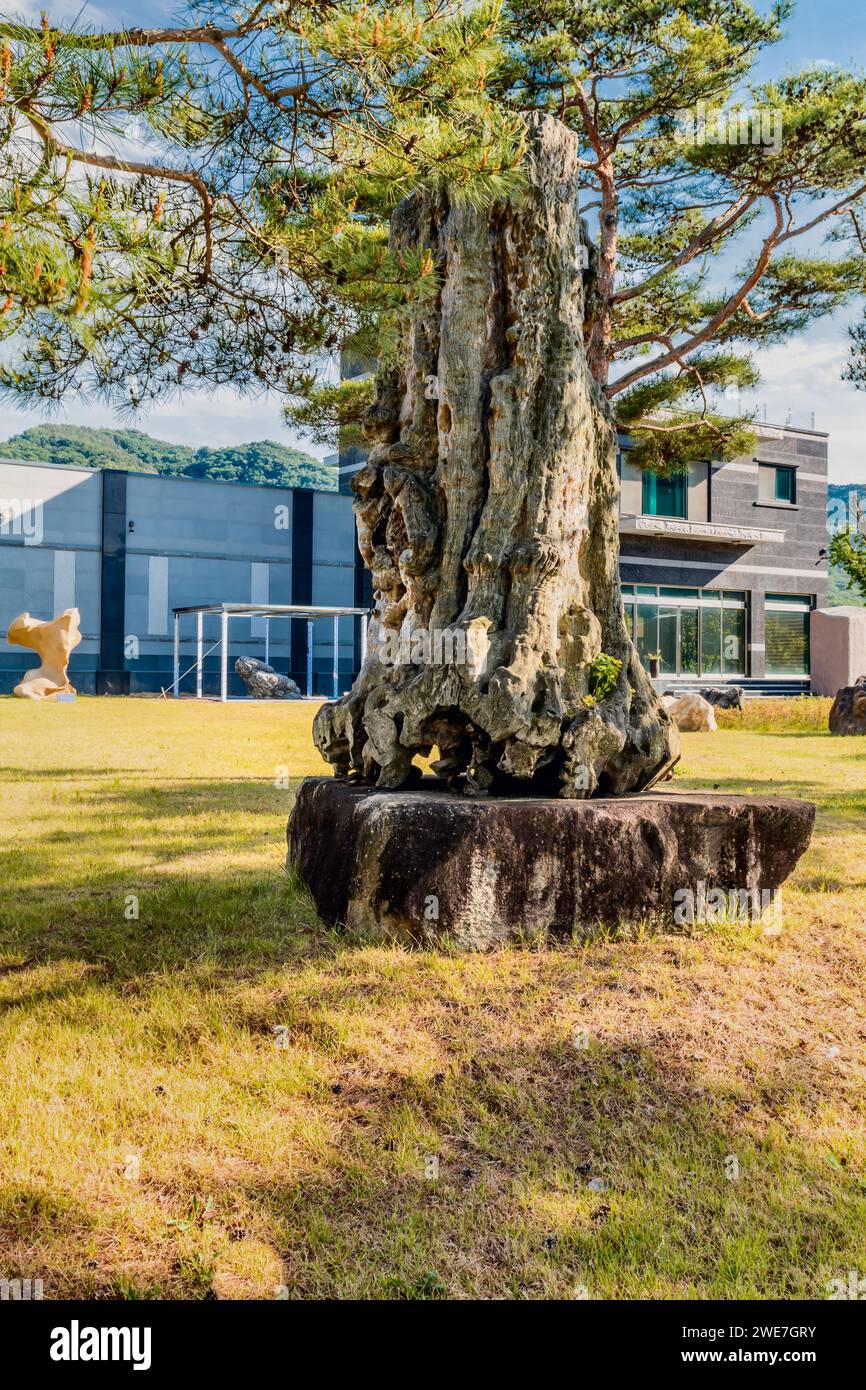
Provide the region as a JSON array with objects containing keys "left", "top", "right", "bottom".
[{"left": 0, "top": 425, "right": 336, "bottom": 492}]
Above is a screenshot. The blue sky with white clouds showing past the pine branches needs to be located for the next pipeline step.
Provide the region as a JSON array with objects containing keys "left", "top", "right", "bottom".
[{"left": 0, "top": 0, "right": 866, "bottom": 482}]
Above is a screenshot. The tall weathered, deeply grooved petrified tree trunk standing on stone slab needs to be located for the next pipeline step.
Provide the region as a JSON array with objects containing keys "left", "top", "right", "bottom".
[{"left": 314, "top": 117, "right": 678, "bottom": 796}]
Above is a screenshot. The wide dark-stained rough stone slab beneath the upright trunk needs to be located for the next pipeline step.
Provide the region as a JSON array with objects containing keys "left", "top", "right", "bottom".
[{"left": 288, "top": 777, "right": 815, "bottom": 949}]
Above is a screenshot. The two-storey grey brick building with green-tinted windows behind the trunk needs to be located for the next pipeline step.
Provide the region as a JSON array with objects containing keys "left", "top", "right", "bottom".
[{"left": 619, "top": 425, "right": 827, "bottom": 694}]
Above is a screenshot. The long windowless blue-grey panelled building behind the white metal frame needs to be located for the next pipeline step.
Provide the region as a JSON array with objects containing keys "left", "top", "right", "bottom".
[{"left": 0, "top": 459, "right": 368, "bottom": 695}]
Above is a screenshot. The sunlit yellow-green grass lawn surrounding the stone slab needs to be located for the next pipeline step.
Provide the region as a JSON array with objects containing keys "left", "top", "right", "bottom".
[{"left": 0, "top": 699, "right": 866, "bottom": 1298}]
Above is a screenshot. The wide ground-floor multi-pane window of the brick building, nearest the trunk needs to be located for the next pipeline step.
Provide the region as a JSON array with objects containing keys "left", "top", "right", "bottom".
[{"left": 623, "top": 584, "right": 746, "bottom": 676}]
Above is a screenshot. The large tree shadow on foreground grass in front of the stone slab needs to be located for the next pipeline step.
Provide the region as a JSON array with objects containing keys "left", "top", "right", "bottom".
[{"left": 16, "top": 1037, "right": 850, "bottom": 1300}]
